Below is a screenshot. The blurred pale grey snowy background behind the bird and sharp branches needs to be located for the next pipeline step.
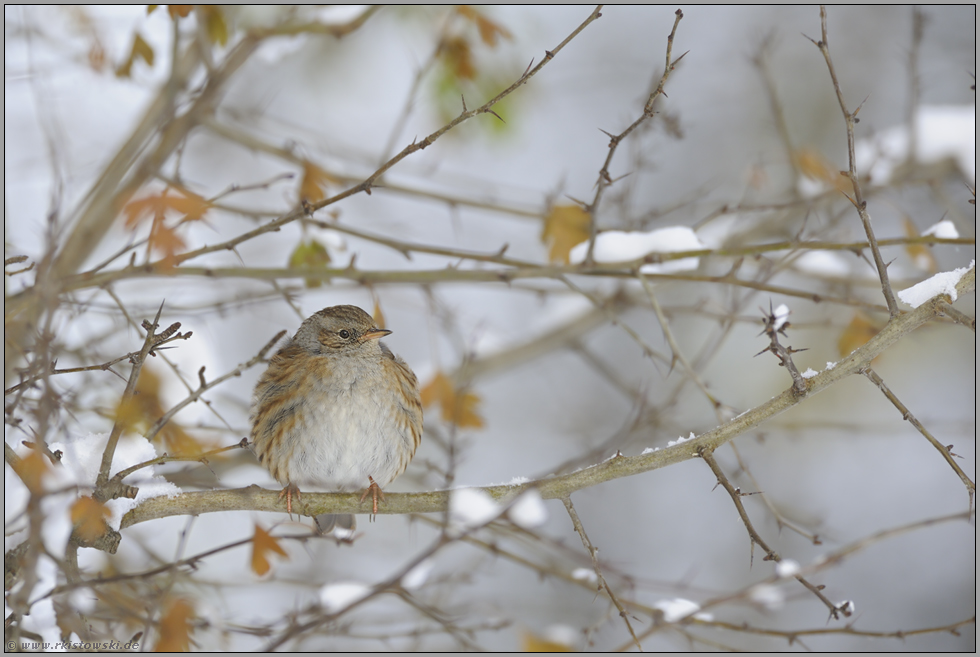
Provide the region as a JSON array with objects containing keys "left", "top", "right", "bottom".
[{"left": 4, "top": 5, "right": 976, "bottom": 651}]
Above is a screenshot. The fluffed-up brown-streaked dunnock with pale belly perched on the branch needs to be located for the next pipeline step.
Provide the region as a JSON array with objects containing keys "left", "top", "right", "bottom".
[{"left": 251, "top": 306, "right": 422, "bottom": 533}]
